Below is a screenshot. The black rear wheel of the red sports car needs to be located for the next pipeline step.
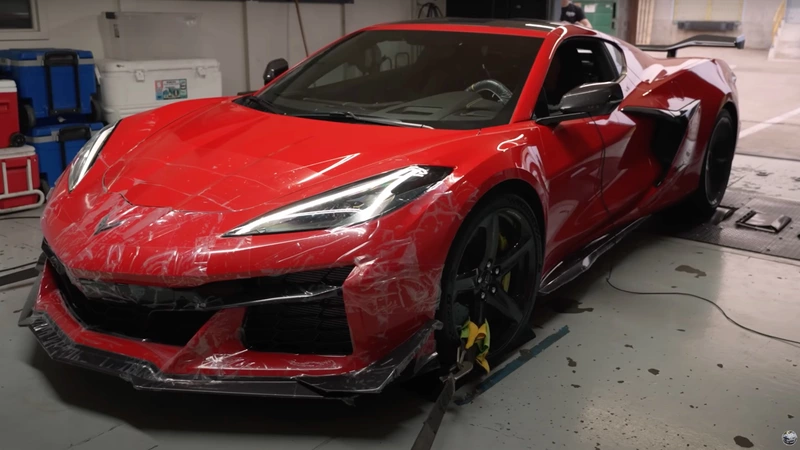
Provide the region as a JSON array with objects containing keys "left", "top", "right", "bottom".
[{"left": 675, "top": 110, "right": 736, "bottom": 223}]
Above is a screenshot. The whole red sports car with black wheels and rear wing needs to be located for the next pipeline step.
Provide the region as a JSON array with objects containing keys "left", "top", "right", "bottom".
[{"left": 20, "top": 19, "right": 743, "bottom": 398}]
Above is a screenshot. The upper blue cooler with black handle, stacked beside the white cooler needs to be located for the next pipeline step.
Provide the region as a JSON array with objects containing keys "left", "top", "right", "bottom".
[{"left": 0, "top": 48, "right": 97, "bottom": 131}]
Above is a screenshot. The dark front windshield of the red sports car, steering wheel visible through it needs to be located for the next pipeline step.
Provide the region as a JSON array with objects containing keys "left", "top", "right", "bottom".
[{"left": 253, "top": 30, "right": 542, "bottom": 129}]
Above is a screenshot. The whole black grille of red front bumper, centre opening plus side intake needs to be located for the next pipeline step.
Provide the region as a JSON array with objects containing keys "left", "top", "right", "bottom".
[{"left": 42, "top": 242, "right": 353, "bottom": 354}]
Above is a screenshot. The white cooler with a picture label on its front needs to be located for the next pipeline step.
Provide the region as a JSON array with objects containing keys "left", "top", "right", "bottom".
[{"left": 96, "top": 59, "right": 222, "bottom": 123}]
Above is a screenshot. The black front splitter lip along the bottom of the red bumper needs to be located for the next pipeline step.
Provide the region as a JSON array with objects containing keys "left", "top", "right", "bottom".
[{"left": 18, "top": 272, "right": 441, "bottom": 400}]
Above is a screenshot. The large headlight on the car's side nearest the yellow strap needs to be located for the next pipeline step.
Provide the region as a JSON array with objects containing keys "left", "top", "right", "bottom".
[{"left": 225, "top": 166, "right": 452, "bottom": 237}]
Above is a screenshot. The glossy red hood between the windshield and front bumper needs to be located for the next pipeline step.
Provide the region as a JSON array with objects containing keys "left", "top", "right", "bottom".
[{"left": 103, "top": 102, "right": 468, "bottom": 211}]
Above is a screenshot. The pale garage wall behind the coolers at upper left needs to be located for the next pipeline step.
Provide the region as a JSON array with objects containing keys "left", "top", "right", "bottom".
[{"left": 0, "top": 0, "right": 445, "bottom": 95}]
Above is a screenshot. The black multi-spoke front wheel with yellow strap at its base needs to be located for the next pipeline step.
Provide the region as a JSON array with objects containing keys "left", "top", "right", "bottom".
[{"left": 436, "top": 193, "right": 543, "bottom": 371}]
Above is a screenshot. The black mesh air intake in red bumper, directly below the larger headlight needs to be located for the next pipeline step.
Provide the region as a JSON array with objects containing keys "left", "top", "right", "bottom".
[{"left": 243, "top": 293, "right": 353, "bottom": 355}]
